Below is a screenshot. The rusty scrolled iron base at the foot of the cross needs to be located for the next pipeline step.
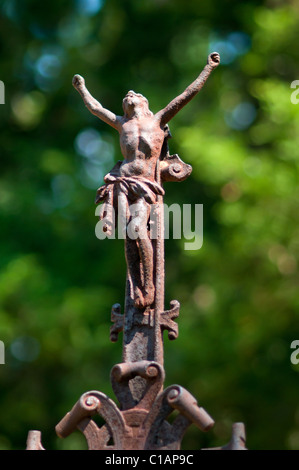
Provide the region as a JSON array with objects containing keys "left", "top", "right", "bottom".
[{"left": 56, "top": 361, "right": 214, "bottom": 450}]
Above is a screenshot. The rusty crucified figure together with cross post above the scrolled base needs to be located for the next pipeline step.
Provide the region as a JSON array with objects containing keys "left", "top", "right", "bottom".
[{"left": 92, "top": 53, "right": 220, "bottom": 382}]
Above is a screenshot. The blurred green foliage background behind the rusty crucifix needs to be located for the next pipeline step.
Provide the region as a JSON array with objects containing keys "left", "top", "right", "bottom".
[{"left": 0, "top": 0, "right": 299, "bottom": 449}]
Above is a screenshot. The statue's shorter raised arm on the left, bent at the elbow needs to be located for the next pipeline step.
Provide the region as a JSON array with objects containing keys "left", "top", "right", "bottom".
[{"left": 73, "top": 75, "right": 121, "bottom": 130}]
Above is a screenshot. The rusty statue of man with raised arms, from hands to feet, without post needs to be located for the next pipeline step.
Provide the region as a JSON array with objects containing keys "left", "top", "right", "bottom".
[{"left": 73, "top": 53, "right": 220, "bottom": 309}]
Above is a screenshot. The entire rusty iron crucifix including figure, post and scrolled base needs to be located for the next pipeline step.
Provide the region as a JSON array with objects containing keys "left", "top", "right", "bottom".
[{"left": 27, "top": 52, "right": 245, "bottom": 450}]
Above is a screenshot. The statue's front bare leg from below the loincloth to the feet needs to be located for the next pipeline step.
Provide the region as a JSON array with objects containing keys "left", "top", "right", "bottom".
[{"left": 128, "top": 198, "right": 155, "bottom": 308}]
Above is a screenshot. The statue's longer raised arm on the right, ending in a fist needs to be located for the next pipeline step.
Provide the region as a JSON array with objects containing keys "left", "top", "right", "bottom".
[{"left": 156, "top": 52, "right": 220, "bottom": 125}]
